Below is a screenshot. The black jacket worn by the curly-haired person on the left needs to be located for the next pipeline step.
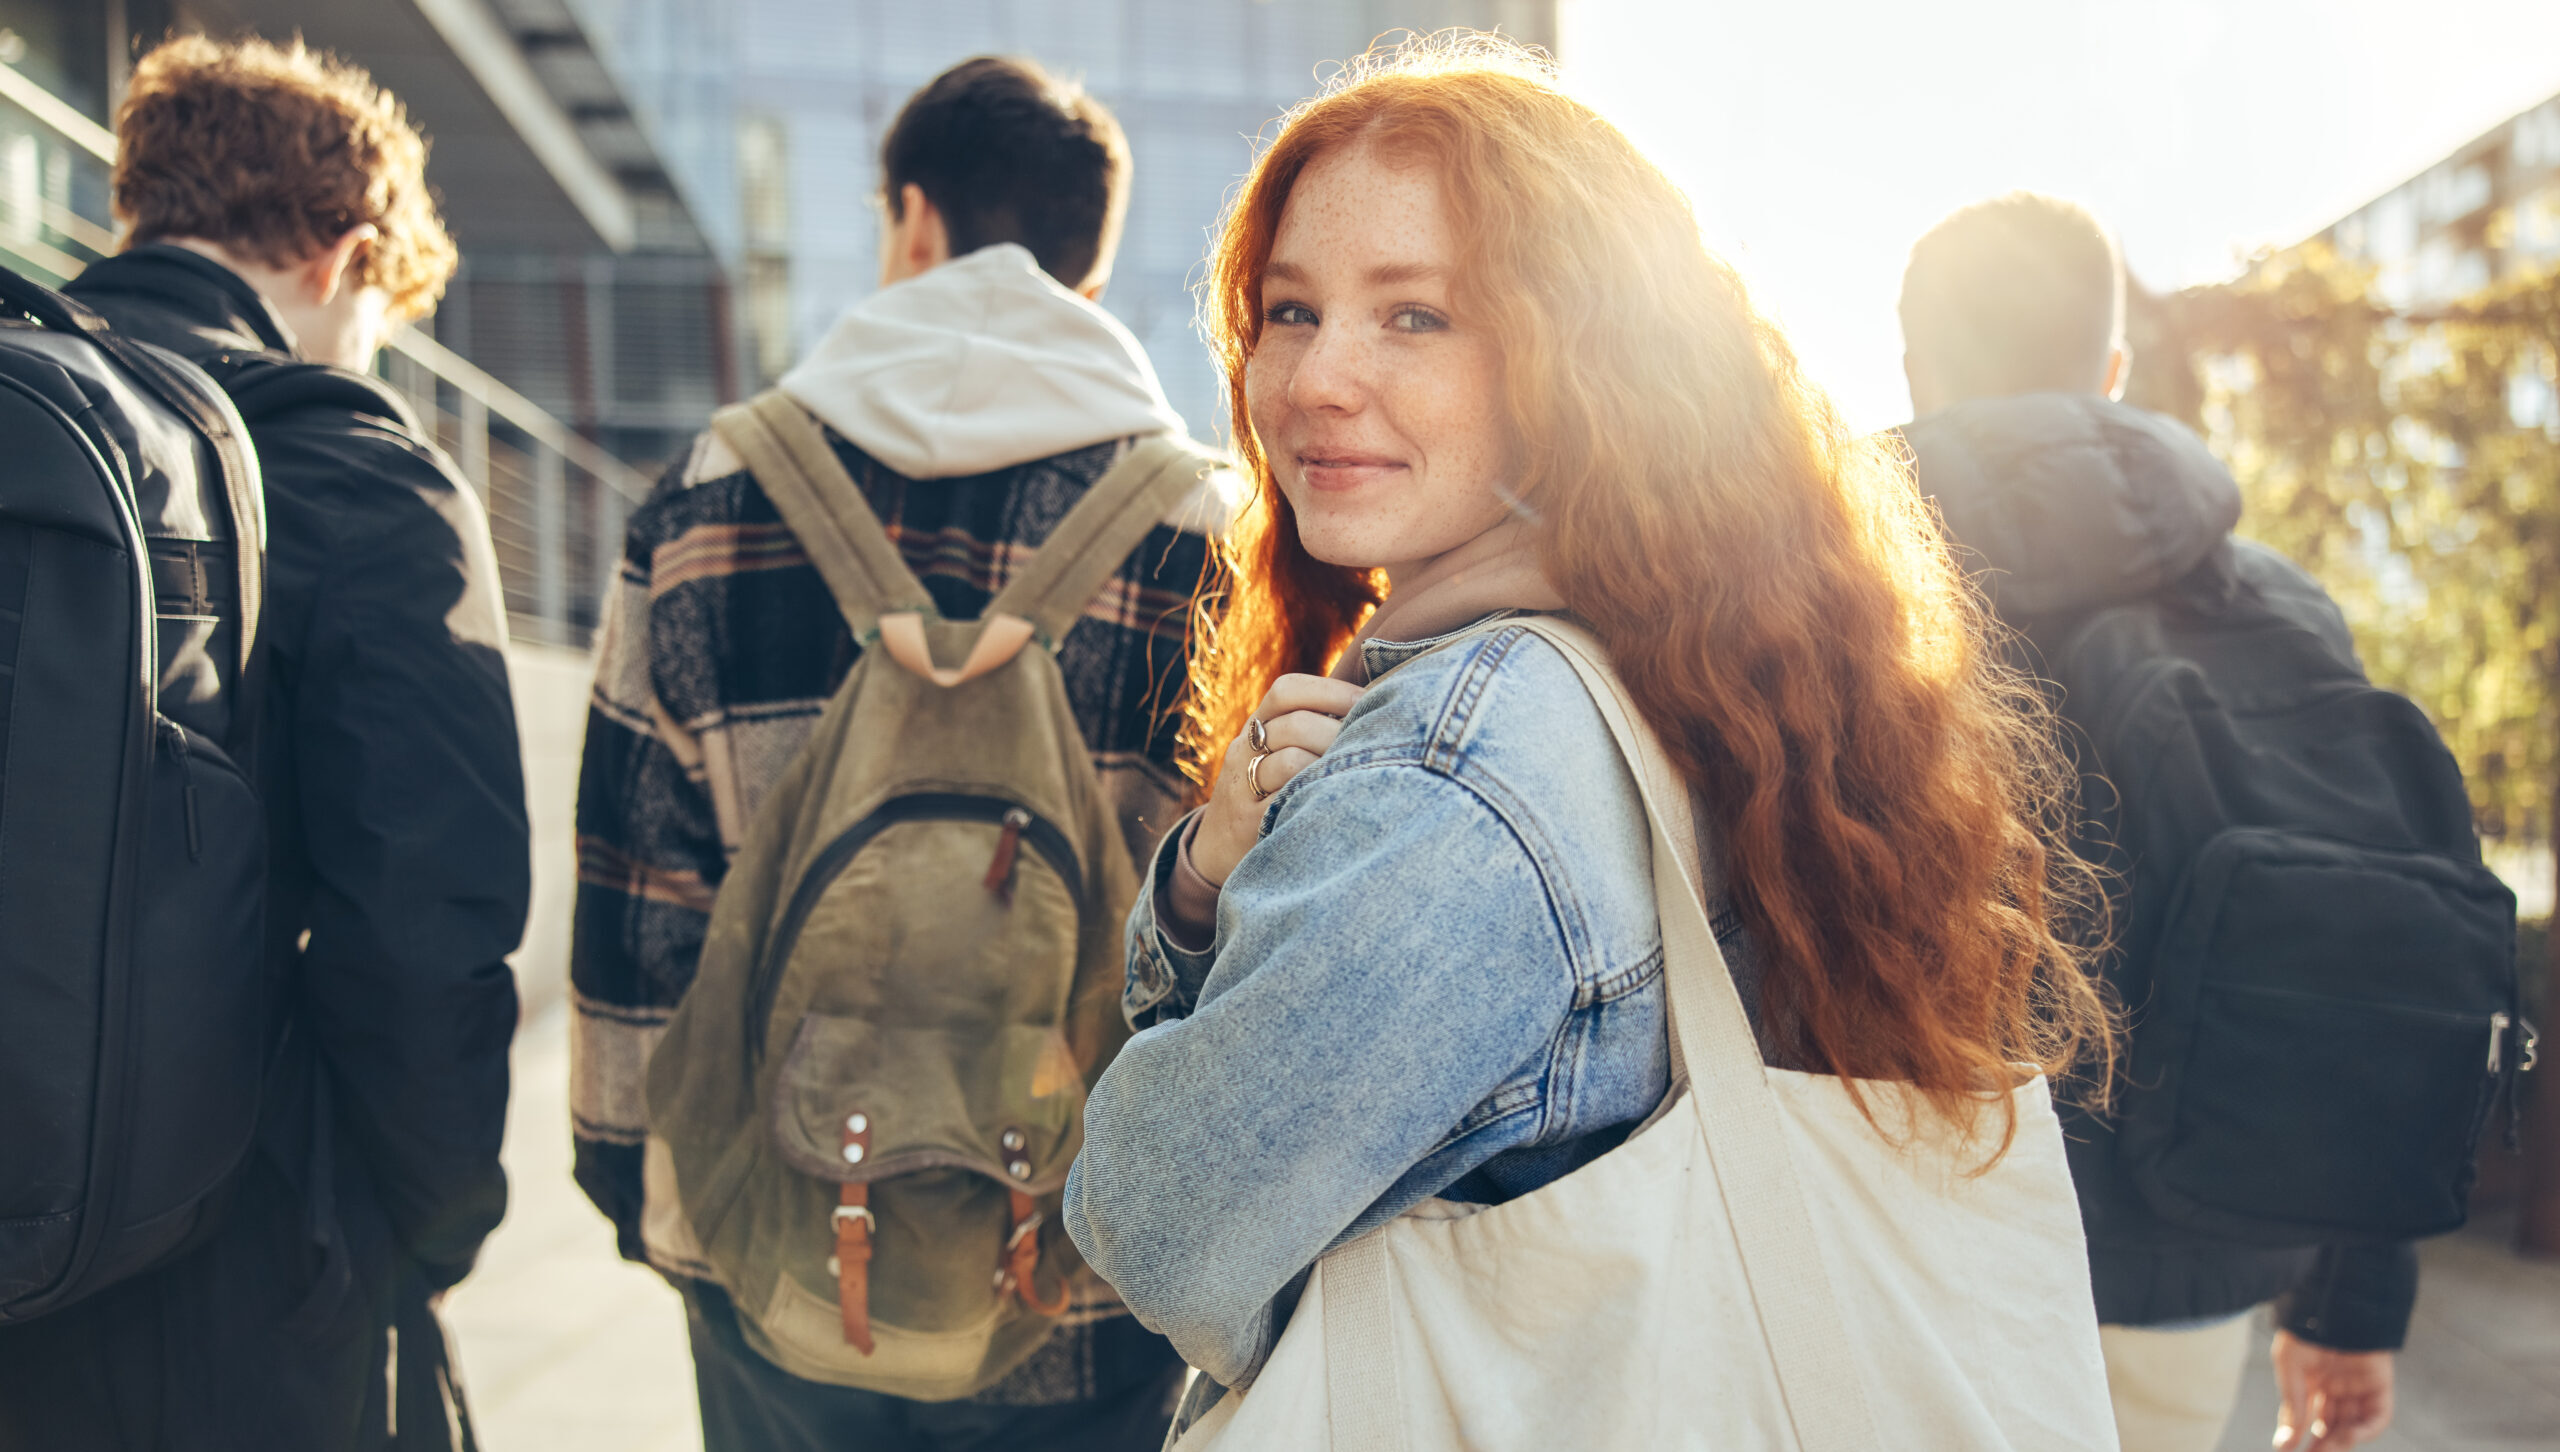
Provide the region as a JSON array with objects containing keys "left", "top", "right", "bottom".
[{"left": 0, "top": 246, "right": 530, "bottom": 1452}]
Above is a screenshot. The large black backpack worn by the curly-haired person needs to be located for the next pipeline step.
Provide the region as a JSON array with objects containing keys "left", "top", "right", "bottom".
[{"left": 0, "top": 269, "right": 276, "bottom": 1324}]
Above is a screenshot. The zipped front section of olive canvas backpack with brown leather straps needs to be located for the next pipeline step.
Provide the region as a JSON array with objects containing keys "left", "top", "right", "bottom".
[{"left": 714, "top": 791, "right": 1085, "bottom": 1396}]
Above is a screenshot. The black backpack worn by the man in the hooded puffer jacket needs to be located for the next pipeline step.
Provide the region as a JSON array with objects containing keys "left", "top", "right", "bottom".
[{"left": 2028, "top": 543, "right": 2532, "bottom": 1247}]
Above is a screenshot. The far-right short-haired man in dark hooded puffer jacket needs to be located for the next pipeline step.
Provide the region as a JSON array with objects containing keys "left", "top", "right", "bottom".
[{"left": 1900, "top": 192, "right": 2417, "bottom": 1452}]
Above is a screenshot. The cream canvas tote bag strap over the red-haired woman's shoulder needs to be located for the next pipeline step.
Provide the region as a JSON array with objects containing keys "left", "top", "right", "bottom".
[{"left": 1324, "top": 617, "right": 1884, "bottom": 1452}]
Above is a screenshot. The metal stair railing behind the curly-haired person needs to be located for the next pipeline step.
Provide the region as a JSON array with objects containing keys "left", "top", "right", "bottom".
[{"left": 0, "top": 64, "right": 650, "bottom": 648}]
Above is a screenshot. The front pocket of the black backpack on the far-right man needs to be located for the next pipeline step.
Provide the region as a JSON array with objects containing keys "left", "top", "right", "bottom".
[{"left": 2117, "top": 830, "right": 2516, "bottom": 1247}]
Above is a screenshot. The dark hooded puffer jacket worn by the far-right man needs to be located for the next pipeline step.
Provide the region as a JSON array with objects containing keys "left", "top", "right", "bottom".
[{"left": 1902, "top": 394, "right": 2417, "bottom": 1350}]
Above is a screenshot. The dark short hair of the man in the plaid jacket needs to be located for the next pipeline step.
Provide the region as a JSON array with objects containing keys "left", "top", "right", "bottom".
[{"left": 881, "top": 56, "right": 1129, "bottom": 287}]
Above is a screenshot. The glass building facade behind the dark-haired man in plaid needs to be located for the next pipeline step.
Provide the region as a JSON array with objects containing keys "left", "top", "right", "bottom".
[{"left": 571, "top": 0, "right": 1556, "bottom": 435}]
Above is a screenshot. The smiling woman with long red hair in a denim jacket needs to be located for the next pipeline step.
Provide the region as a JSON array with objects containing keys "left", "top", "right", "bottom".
[{"left": 1065, "top": 38, "right": 2107, "bottom": 1444}]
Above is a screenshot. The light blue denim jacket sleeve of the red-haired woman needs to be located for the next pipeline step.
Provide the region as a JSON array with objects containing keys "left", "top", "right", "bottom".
[{"left": 1065, "top": 747, "right": 1574, "bottom": 1385}]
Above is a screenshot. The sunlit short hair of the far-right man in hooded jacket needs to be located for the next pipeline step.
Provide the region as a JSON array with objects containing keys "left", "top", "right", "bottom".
[{"left": 1902, "top": 192, "right": 2125, "bottom": 397}]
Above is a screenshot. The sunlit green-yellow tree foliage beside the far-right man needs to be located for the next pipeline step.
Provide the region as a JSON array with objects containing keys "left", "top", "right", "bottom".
[{"left": 2127, "top": 243, "right": 2560, "bottom": 843}]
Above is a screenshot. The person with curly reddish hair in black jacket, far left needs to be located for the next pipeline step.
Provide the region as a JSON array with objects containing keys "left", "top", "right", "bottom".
[{"left": 0, "top": 38, "right": 530, "bottom": 1452}]
